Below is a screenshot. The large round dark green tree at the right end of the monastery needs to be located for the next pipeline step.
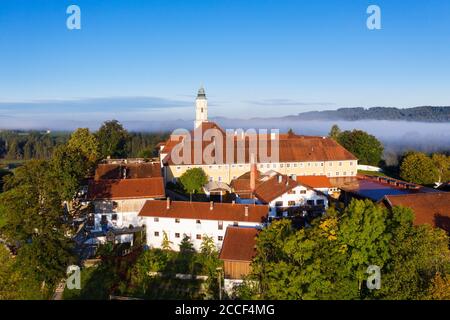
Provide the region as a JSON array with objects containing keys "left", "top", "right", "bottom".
[{"left": 338, "top": 130, "right": 384, "bottom": 166}]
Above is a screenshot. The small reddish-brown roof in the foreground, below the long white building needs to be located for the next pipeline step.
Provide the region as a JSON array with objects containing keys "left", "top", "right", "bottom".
[{"left": 219, "top": 227, "right": 258, "bottom": 261}]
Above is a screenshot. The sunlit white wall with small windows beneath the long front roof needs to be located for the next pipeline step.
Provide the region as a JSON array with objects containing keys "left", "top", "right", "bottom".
[{"left": 144, "top": 217, "right": 261, "bottom": 251}]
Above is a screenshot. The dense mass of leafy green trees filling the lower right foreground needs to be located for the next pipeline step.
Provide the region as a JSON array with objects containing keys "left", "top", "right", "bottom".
[{"left": 246, "top": 200, "right": 450, "bottom": 299}]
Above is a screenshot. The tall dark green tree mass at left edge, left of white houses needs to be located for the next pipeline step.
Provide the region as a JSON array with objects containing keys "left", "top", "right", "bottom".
[{"left": 0, "top": 160, "right": 73, "bottom": 289}]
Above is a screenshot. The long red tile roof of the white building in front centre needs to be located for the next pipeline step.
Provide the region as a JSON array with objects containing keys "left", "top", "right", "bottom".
[{"left": 139, "top": 200, "right": 269, "bottom": 223}]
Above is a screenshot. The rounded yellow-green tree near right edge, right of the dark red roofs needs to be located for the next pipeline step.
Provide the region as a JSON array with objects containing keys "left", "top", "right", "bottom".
[{"left": 400, "top": 152, "right": 439, "bottom": 184}]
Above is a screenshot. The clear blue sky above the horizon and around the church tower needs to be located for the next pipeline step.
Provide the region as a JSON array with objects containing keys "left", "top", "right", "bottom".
[{"left": 0, "top": 0, "right": 450, "bottom": 128}]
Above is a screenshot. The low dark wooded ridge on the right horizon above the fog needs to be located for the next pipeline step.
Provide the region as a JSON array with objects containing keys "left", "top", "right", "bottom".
[{"left": 283, "top": 107, "right": 450, "bottom": 122}]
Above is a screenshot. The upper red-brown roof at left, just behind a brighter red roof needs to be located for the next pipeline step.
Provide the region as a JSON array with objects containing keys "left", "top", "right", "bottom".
[{"left": 95, "top": 162, "right": 162, "bottom": 180}]
